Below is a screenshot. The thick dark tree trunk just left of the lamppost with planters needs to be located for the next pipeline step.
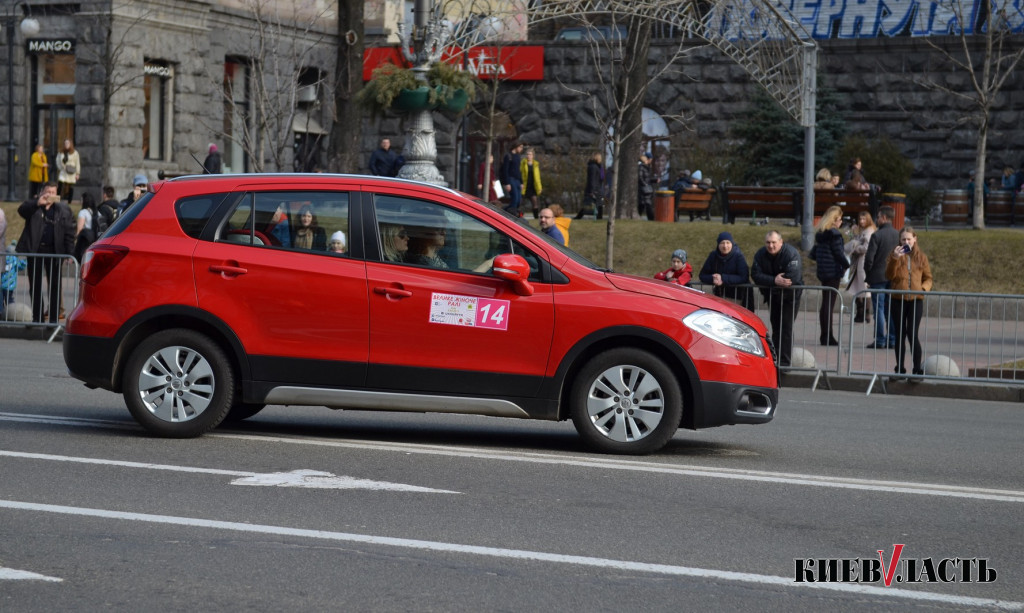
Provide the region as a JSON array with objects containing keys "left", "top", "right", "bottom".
[{"left": 328, "top": 0, "right": 365, "bottom": 173}]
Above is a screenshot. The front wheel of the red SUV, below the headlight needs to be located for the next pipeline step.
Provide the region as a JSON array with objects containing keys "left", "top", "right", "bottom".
[{"left": 569, "top": 348, "right": 683, "bottom": 454}]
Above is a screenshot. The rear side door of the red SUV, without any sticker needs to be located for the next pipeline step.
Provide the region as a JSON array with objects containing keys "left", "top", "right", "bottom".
[{"left": 194, "top": 190, "right": 369, "bottom": 387}]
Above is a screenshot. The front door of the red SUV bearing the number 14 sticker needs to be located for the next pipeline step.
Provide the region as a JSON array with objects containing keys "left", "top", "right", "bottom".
[{"left": 367, "top": 193, "right": 554, "bottom": 397}]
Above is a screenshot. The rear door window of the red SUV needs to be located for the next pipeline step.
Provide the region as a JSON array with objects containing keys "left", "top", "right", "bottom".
[{"left": 219, "top": 191, "right": 349, "bottom": 251}]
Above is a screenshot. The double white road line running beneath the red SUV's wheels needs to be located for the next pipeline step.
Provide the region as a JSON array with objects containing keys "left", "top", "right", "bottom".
[{"left": 0, "top": 412, "right": 1024, "bottom": 502}]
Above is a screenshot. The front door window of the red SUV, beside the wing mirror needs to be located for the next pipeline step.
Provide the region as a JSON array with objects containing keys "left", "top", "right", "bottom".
[{"left": 374, "top": 194, "right": 540, "bottom": 276}]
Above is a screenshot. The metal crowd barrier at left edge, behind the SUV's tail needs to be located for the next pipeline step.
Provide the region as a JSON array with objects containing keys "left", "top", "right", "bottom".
[{"left": 0, "top": 252, "right": 79, "bottom": 342}]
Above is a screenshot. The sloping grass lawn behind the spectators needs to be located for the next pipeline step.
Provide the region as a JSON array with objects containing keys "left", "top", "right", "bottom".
[{"left": 8, "top": 203, "right": 1024, "bottom": 294}]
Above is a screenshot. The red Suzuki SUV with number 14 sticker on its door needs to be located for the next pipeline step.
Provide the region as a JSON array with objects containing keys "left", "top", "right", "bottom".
[{"left": 63, "top": 174, "right": 778, "bottom": 453}]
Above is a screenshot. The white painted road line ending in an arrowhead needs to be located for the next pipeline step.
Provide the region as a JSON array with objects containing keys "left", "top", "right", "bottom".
[{"left": 0, "top": 449, "right": 460, "bottom": 494}]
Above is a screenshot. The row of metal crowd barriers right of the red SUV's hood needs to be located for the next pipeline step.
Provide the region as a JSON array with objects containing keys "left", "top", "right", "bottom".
[{"left": 693, "top": 283, "right": 1024, "bottom": 394}]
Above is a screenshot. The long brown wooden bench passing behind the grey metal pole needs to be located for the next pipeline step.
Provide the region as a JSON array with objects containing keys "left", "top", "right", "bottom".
[{"left": 721, "top": 185, "right": 878, "bottom": 223}]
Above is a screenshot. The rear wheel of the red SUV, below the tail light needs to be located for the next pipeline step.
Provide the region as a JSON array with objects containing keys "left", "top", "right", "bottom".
[{"left": 122, "top": 330, "right": 234, "bottom": 438}]
